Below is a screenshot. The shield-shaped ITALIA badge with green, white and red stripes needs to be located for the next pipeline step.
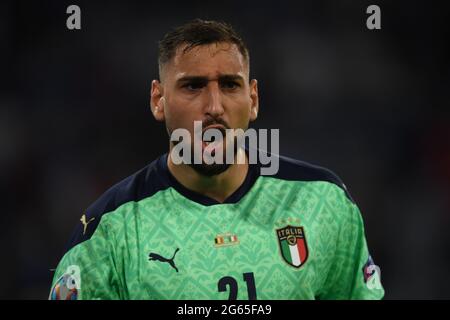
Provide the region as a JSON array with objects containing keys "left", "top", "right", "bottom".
[{"left": 277, "top": 225, "right": 308, "bottom": 268}]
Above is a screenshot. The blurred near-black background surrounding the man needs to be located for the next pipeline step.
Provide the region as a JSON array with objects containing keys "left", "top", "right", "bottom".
[{"left": 0, "top": 0, "right": 450, "bottom": 299}]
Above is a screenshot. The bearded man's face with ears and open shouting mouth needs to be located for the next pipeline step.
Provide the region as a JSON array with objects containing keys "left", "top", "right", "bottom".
[{"left": 151, "top": 42, "right": 258, "bottom": 175}]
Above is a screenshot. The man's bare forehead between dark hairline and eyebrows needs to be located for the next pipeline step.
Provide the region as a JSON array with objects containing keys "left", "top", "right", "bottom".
[{"left": 168, "top": 43, "right": 248, "bottom": 80}]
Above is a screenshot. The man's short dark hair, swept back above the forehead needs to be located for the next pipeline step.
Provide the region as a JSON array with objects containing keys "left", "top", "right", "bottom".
[{"left": 158, "top": 19, "right": 250, "bottom": 77}]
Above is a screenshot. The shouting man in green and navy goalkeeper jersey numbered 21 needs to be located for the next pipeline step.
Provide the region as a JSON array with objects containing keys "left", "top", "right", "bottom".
[{"left": 50, "top": 20, "right": 384, "bottom": 300}]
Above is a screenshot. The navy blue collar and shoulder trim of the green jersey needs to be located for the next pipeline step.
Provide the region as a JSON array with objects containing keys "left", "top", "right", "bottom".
[{"left": 61, "top": 153, "right": 353, "bottom": 252}]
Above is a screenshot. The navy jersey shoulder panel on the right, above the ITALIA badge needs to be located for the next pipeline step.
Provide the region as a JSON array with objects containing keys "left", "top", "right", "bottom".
[{"left": 262, "top": 154, "right": 354, "bottom": 202}]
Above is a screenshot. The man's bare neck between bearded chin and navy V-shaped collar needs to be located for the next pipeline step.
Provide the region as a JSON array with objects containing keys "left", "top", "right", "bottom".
[{"left": 167, "top": 151, "right": 248, "bottom": 203}]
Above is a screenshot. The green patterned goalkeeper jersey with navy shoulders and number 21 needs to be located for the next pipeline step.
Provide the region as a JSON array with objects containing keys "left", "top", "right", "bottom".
[{"left": 49, "top": 154, "right": 384, "bottom": 300}]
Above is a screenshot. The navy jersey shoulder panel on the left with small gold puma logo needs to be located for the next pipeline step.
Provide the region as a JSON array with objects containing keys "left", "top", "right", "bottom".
[{"left": 65, "top": 157, "right": 168, "bottom": 252}]
